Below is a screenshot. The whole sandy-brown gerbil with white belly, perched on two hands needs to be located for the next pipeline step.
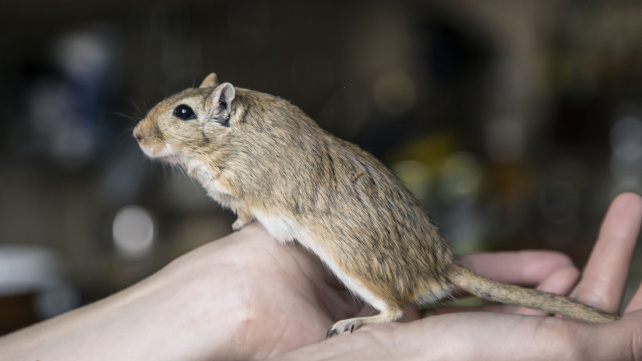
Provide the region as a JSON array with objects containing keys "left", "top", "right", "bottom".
[{"left": 134, "top": 73, "right": 619, "bottom": 336}]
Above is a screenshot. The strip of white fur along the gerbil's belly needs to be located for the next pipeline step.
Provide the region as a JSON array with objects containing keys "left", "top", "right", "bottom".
[{"left": 252, "top": 209, "right": 389, "bottom": 311}]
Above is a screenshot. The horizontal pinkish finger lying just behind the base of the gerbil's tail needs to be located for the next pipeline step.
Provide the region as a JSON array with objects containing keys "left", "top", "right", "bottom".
[{"left": 460, "top": 251, "right": 573, "bottom": 285}]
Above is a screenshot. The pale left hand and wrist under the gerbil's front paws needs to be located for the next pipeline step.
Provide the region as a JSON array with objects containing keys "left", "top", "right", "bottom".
[{"left": 0, "top": 219, "right": 363, "bottom": 361}]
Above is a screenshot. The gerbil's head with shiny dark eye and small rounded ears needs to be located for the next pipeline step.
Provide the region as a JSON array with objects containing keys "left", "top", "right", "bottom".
[{"left": 134, "top": 73, "right": 236, "bottom": 162}]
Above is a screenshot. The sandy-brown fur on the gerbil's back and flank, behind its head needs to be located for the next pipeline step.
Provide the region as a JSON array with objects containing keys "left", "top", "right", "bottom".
[{"left": 219, "top": 86, "right": 453, "bottom": 305}]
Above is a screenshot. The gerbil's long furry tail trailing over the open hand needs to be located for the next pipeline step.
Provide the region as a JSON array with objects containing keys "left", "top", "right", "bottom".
[{"left": 448, "top": 263, "right": 620, "bottom": 323}]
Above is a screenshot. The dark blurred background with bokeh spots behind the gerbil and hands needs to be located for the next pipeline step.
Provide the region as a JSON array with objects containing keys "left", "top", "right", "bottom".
[{"left": 0, "top": 0, "right": 642, "bottom": 334}]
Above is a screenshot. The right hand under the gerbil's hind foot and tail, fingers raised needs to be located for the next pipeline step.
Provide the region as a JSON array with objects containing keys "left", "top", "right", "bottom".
[{"left": 277, "top": 193, "right": 642, "bottom": 360}]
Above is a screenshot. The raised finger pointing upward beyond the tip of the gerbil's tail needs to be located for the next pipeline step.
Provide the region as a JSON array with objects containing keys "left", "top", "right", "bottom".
[{"left": 572, "top": 193, "right": 642, "bottom": 312}]
